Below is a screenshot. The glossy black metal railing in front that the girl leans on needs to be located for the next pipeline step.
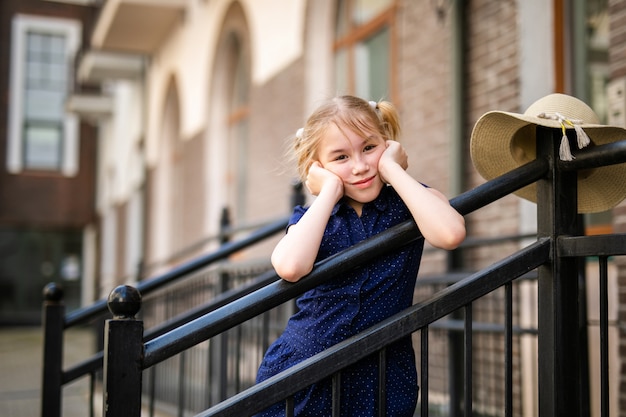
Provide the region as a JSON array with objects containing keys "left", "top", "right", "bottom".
[{"left": 44, "top": 128, "right": 626, "bottom": 417}]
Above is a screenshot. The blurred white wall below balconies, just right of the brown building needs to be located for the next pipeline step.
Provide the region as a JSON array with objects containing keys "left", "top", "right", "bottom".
[{"left": 89, "top": 79, "right": 144, "bottom": 286}]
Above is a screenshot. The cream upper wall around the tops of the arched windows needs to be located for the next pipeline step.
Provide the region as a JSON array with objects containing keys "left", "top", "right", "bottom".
[{"left": 146, "top": 0, "right": 306, "bottom": 165}]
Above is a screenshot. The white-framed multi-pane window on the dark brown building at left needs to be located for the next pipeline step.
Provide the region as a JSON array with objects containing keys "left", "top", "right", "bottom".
[{"left": 7, "top": 15, "right": 81, "bottom": 176}]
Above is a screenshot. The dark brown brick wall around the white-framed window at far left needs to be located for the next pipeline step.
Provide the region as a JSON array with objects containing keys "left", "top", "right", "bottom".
[{"left": 0, "top": 0, "right": 97, "bottom": 228}]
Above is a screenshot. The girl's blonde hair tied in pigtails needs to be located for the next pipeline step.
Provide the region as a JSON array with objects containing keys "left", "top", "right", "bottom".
[{"left": 293, "top": 96, "right": 400, "bottom": 181}]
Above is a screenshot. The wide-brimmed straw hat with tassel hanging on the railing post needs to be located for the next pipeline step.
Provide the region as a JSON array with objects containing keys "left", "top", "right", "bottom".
[{"left": 470, "top": 94, "right": 626, "bottom": 213}]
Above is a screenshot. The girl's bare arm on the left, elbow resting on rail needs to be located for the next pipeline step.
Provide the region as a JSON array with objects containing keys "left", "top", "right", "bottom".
[{"left": 271, "top": 162, "right": 343, "bottom": 282}]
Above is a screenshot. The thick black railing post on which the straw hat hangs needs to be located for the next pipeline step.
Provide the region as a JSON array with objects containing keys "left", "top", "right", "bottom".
[{"left": 537, "top": 127, "right": 580, "bottom": 417}]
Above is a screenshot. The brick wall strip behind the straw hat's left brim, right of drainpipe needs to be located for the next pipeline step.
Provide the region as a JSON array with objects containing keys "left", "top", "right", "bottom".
[{"left": 465, "top": 0, "right": 524, "bottom": 415}]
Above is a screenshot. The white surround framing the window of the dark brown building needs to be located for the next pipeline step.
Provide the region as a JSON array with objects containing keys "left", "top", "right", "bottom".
[{"left": 6, "top": 14, "right": 82, "bottom": 177}]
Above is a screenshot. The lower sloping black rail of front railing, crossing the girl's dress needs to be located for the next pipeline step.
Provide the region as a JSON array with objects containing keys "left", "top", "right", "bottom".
[{"left": 196, "top": 238, "right": 550, "bottom": 417}]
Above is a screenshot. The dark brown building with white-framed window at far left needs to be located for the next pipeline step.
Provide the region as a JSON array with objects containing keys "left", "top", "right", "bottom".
[{"left": 0, "top": 0, "right": 97, "bottom": 324}]
